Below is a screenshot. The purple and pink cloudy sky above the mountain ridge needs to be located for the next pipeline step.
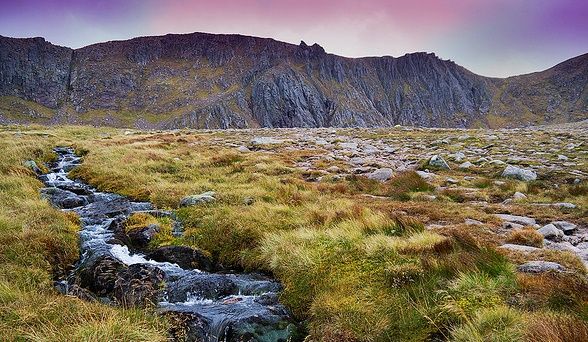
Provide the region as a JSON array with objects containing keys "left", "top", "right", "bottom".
[{"left": 0, "top": 0, "right": 588, "bottom": 77}]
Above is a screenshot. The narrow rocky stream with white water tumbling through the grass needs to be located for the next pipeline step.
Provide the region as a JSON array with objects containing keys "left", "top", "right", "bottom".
[{"left": 40, "top": 148, "right": 295, "bottom": 341}]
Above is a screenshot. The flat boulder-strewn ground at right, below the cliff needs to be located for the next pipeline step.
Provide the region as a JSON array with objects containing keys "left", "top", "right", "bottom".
[{"left": 207, "top": 121, "right": 588, "bottom": 272}]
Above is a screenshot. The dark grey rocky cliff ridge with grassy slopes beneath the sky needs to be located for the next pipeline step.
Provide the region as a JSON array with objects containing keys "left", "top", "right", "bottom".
[{"left": 0, "top": 33, "right": 588, "bottom": 128}]
